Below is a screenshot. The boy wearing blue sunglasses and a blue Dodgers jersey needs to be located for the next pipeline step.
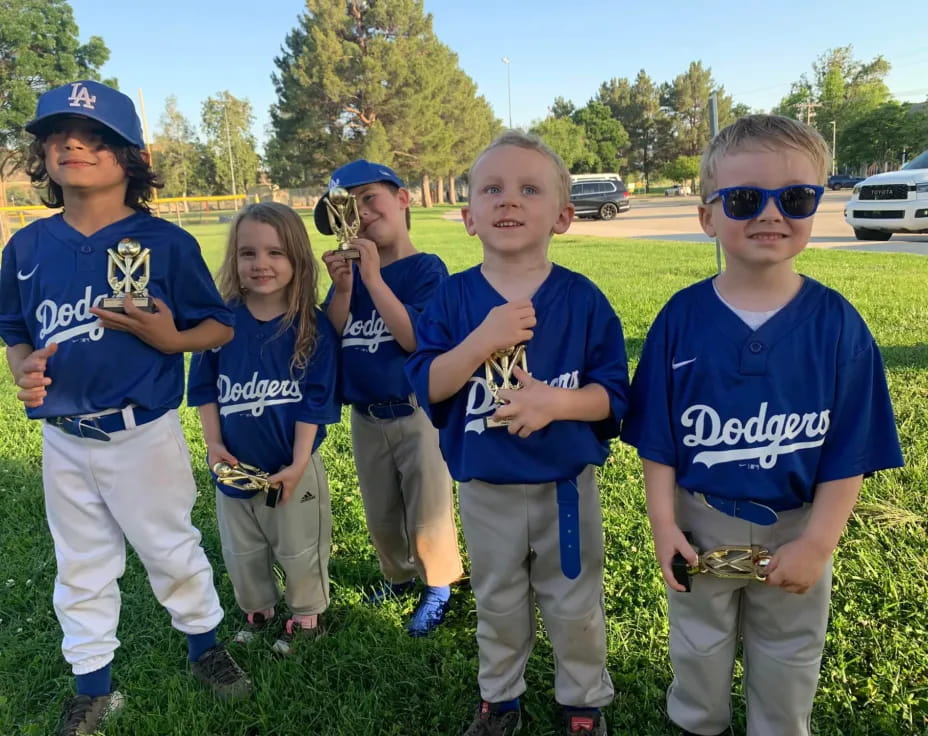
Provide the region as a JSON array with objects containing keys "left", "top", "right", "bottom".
[{"left": 622, "top": 115, "right": 902, "bottom": 736}]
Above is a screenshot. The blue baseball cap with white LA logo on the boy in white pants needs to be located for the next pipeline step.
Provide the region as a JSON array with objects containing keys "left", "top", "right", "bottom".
[{"left": 26, "top": 79, "right": 145, "bottom": 148}]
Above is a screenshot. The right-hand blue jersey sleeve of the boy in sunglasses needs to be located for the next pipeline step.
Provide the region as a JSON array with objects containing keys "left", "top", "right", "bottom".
[{"left": 816, "top": 339, "right": 903, "bottom": 483}]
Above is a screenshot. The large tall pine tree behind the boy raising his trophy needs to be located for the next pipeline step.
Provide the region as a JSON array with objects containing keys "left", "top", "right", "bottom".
[{"left": 266, "top": 0, "right": 499, "bottom": 186}]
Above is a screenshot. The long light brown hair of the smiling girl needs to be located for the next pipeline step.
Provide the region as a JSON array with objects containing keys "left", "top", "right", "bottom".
[{"left": 218, "top": 202, "right": 319, "bottom": 376}]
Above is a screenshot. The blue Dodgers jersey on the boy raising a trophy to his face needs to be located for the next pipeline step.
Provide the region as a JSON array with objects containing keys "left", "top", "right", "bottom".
[{"left": 323, "top": 253, "right": 448, "bottom": 404}]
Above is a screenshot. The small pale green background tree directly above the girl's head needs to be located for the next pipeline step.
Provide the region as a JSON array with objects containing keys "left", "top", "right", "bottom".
[{"left": 202, "top": 90, "right": 260, "bottom": 194}]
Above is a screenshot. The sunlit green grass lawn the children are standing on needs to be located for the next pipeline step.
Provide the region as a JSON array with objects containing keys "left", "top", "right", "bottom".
[{"left": 0, "top": 208, "right": 928, "bottom": 736}]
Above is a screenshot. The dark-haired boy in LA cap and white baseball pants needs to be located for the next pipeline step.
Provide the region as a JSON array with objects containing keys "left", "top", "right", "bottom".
[{"left": 0, "top": 81, "right": 252, "bottom": 736}]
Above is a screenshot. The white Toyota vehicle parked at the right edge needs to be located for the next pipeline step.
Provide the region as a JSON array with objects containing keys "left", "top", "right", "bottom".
[{"left": 844, "top": 151, "right": 928, "bottom": 240}]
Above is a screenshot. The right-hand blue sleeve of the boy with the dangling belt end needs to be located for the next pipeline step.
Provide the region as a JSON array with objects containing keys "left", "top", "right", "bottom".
[{"left": 581, "top": 289, "right": 628, "bottom": 439}]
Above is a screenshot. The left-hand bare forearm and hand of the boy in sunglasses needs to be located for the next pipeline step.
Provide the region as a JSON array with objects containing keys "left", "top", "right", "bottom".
[{"left": 641, "top": 458, "right": 696, "bottom": 593}]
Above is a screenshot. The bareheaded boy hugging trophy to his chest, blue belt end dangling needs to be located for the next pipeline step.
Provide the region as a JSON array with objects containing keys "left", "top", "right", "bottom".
[{"left": 407, "top": 131, "right": 628, "bottom": 736}]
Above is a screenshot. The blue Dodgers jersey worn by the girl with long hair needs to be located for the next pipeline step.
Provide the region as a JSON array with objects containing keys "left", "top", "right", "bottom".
[{"left": 187, "top": 304, "right": 341, "bottom": 498}]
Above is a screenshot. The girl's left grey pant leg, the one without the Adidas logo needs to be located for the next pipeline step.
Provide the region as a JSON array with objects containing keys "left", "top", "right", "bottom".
[{"left": 216, "top": 488, "right": 280, "bottom": 613}]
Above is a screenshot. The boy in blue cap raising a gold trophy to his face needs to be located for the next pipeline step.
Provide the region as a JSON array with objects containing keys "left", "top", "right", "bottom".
[{"left": 315, "top": 159, "right": 463, "bottom": 636}]
